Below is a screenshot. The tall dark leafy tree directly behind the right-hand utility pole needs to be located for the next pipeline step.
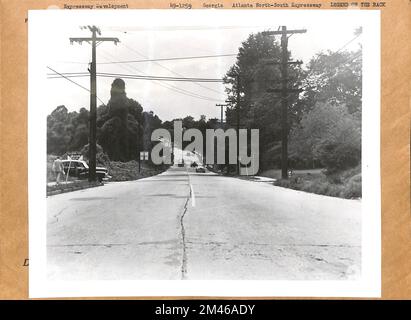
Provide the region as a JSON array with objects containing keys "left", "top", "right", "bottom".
[{"left": 224, "top": 33, "right": 303, "bottom": 169}]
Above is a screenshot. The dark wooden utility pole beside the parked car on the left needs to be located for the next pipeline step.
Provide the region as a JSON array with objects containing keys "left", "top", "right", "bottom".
[{"left": 70, "top": 26, "right": 120, "bottom": 182}]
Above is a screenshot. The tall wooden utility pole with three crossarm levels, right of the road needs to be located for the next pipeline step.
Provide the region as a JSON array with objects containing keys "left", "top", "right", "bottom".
[{"left": 263, "top": 26, "right": 307, "bottom": 179}]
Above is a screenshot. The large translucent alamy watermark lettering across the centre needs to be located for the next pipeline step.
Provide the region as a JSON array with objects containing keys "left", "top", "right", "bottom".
[{"left": 151, "top": 120, "right": 259, "bottom": 175}]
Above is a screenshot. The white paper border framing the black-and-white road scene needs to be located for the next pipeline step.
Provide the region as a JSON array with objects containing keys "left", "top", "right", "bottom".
[{"left": 28, "top": 9, "right": 381, "bottom": 298}]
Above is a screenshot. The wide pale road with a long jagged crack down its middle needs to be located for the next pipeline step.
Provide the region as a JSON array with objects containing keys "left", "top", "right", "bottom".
[{"left": 47, "top": 168, "right": 361, "bottom": 280}]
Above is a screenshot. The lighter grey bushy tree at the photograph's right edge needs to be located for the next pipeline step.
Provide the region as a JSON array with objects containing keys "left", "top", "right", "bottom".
[{"left": 290, "top": 48, "right": 362, "bottom": 173}]
